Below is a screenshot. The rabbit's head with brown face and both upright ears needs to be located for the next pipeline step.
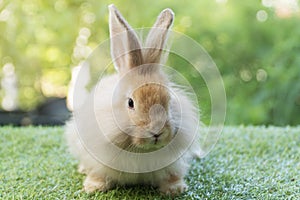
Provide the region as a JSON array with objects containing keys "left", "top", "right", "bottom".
[{"left": 109, "top": 5, "right": 176, "bottom": 150}]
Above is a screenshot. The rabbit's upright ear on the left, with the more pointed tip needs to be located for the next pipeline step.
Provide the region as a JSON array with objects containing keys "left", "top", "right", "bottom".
[{"left": 108, "top": 4, "right": 143, "bottom": 72}]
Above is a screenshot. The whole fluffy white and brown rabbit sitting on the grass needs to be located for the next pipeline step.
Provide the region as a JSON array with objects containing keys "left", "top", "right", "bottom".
[{"left": 65, "top": 5, "right": 201, "bottom": 195}]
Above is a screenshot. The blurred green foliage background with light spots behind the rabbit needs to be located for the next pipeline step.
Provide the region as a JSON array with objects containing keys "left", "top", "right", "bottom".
[{"left": 0, "top": 0, "right": 300, "bottom": 125}]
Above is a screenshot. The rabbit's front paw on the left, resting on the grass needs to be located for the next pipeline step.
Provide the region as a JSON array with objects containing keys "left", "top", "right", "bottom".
[{"left": 83, "top": 175, "right": 111, "bottom": 193}]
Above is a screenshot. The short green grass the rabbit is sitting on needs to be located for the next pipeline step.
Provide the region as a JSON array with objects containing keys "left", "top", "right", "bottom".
[{"left": 0, "top": 127, "right": 300, "bottom": 199}]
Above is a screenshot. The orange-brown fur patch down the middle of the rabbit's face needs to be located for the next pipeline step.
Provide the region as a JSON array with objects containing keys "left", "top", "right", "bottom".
[{"left": 123, "top": 83, "right": 172, "bottom": 151}]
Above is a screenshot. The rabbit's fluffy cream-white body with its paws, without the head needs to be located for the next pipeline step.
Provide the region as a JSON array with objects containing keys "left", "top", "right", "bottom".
[{"left": 65, "top": 4, "right": 201, "bottom": 194}]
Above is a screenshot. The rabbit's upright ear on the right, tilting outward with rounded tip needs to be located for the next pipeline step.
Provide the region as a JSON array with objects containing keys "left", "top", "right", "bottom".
[{"left": 143, "top": 8, "right": 174, "bottom": 63}]
